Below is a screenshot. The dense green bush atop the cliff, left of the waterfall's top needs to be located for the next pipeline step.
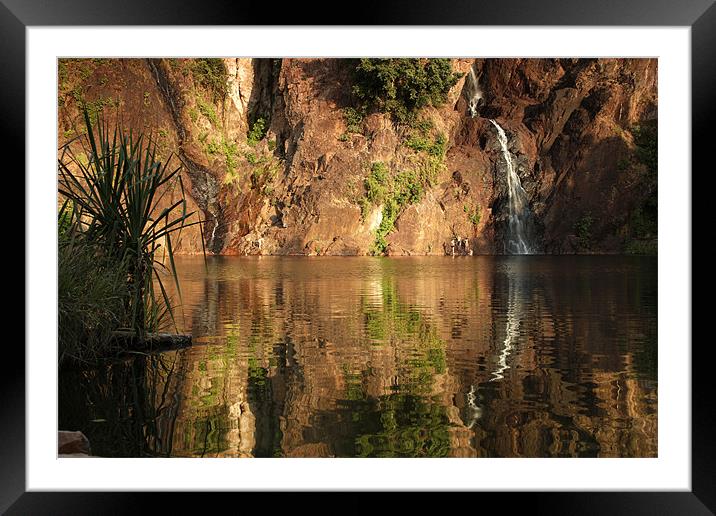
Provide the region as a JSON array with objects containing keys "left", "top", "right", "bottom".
[{"left": 353, "top": 58, "right": 462, "bottom": 123}]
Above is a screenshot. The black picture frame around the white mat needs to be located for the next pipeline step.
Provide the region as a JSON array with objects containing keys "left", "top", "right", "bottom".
[{"left": 0, "top": 0, "right": 704, "bottom": 515}]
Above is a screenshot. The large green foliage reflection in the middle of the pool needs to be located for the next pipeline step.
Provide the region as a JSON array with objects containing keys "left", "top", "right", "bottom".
[{"left": 337, "top": 274, "right": 450, "bottom": 457}]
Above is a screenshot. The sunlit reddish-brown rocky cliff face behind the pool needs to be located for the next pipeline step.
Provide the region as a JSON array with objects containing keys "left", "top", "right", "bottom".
[{"left": 58, "top": 59, "right": 657, "bottom": 255}]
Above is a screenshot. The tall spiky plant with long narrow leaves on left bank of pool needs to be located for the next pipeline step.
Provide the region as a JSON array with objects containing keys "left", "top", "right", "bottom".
[{"left": 58, "top": 111, "right": 203, "bottom": 339}]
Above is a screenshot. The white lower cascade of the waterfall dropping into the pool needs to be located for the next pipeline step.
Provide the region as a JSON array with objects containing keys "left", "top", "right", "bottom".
[{"left": 490, "top": 119, "right": 532, "bottom": 254}]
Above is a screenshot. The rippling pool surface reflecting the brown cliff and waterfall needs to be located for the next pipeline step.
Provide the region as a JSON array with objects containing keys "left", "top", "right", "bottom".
[{"left": 61, "top": 257, "right": 657, "bottom": 457}]
